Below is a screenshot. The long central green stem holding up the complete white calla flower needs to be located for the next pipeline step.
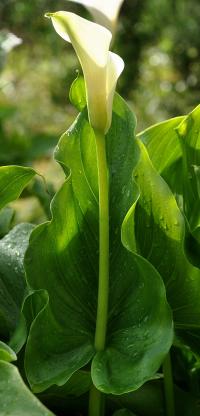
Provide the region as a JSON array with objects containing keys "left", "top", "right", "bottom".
[{"left": 89, "top": 131, "right": 109, "bottom": 416}]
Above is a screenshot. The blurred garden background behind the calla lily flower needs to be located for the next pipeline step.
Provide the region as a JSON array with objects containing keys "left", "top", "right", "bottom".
[{"left": 0, "top": 0, "right": 200, "bottom": 224}]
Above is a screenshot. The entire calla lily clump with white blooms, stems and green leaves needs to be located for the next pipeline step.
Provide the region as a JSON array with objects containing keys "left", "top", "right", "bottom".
[{"left": 0, "top": 4, "right": 200, "bottom": 416}]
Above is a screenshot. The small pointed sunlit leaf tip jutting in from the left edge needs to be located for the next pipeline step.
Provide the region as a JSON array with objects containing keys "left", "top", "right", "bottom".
[{"left": 0, "top": 166, "right": 35, "bottom": 209}]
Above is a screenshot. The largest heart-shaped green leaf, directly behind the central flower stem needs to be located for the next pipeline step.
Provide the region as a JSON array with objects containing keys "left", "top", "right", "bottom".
[{"left": 25, "top": 91, "right": 172, "bottom": 394}]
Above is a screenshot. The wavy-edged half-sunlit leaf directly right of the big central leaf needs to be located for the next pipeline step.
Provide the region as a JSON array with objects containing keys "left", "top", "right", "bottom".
[{"left": 122, "top": 142, "right": 200, "bottom": 349}]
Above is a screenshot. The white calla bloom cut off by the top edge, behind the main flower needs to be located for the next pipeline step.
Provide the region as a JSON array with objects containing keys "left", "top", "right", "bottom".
[{"left": 66, "top": 0, "right": 124, "bottom": 33}]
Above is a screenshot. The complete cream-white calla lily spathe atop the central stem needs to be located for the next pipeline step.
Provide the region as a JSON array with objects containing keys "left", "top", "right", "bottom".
[{"left": 46, "top": 11, "right": 124, "bottom": 133}]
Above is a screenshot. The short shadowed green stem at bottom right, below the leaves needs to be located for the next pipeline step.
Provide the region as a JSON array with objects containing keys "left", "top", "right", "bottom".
[{"left": 163, "top": 352, "right": 175, "bottom": 416}]
